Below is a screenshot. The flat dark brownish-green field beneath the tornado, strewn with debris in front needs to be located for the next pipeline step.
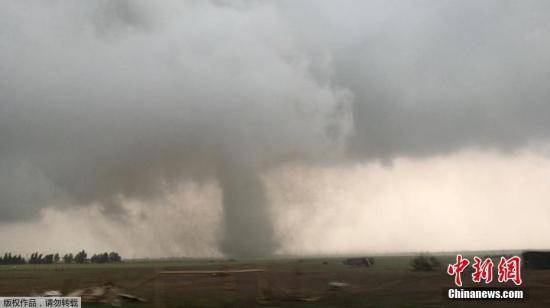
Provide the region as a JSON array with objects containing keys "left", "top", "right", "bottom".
[{"left": 0, "top": 256, "right": 550, "bottom": 307}]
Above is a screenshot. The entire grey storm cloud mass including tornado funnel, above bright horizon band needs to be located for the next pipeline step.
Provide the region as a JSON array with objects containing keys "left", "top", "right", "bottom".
[{"left": 0, "top": 0, "right": 550, "bottom": 254}]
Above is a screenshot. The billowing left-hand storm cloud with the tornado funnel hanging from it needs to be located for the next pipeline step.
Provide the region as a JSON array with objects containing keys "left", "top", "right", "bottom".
[{"left": 0, "top": 1, "right": 351, "bottom": 255}]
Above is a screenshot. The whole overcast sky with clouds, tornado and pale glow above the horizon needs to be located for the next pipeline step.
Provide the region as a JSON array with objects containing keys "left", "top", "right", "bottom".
[{"left": 0, "top": 0, "right": 550, "bottom": 256}]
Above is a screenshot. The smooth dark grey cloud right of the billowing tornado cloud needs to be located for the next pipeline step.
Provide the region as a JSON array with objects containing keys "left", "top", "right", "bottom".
[{"left": 282, "top": 1, "right": 550, "bottom": 160}]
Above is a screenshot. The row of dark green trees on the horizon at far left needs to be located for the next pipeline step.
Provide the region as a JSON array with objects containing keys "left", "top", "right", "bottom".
[{"left": 0, "top": 250, "right": 122, "bottom": 264}]
